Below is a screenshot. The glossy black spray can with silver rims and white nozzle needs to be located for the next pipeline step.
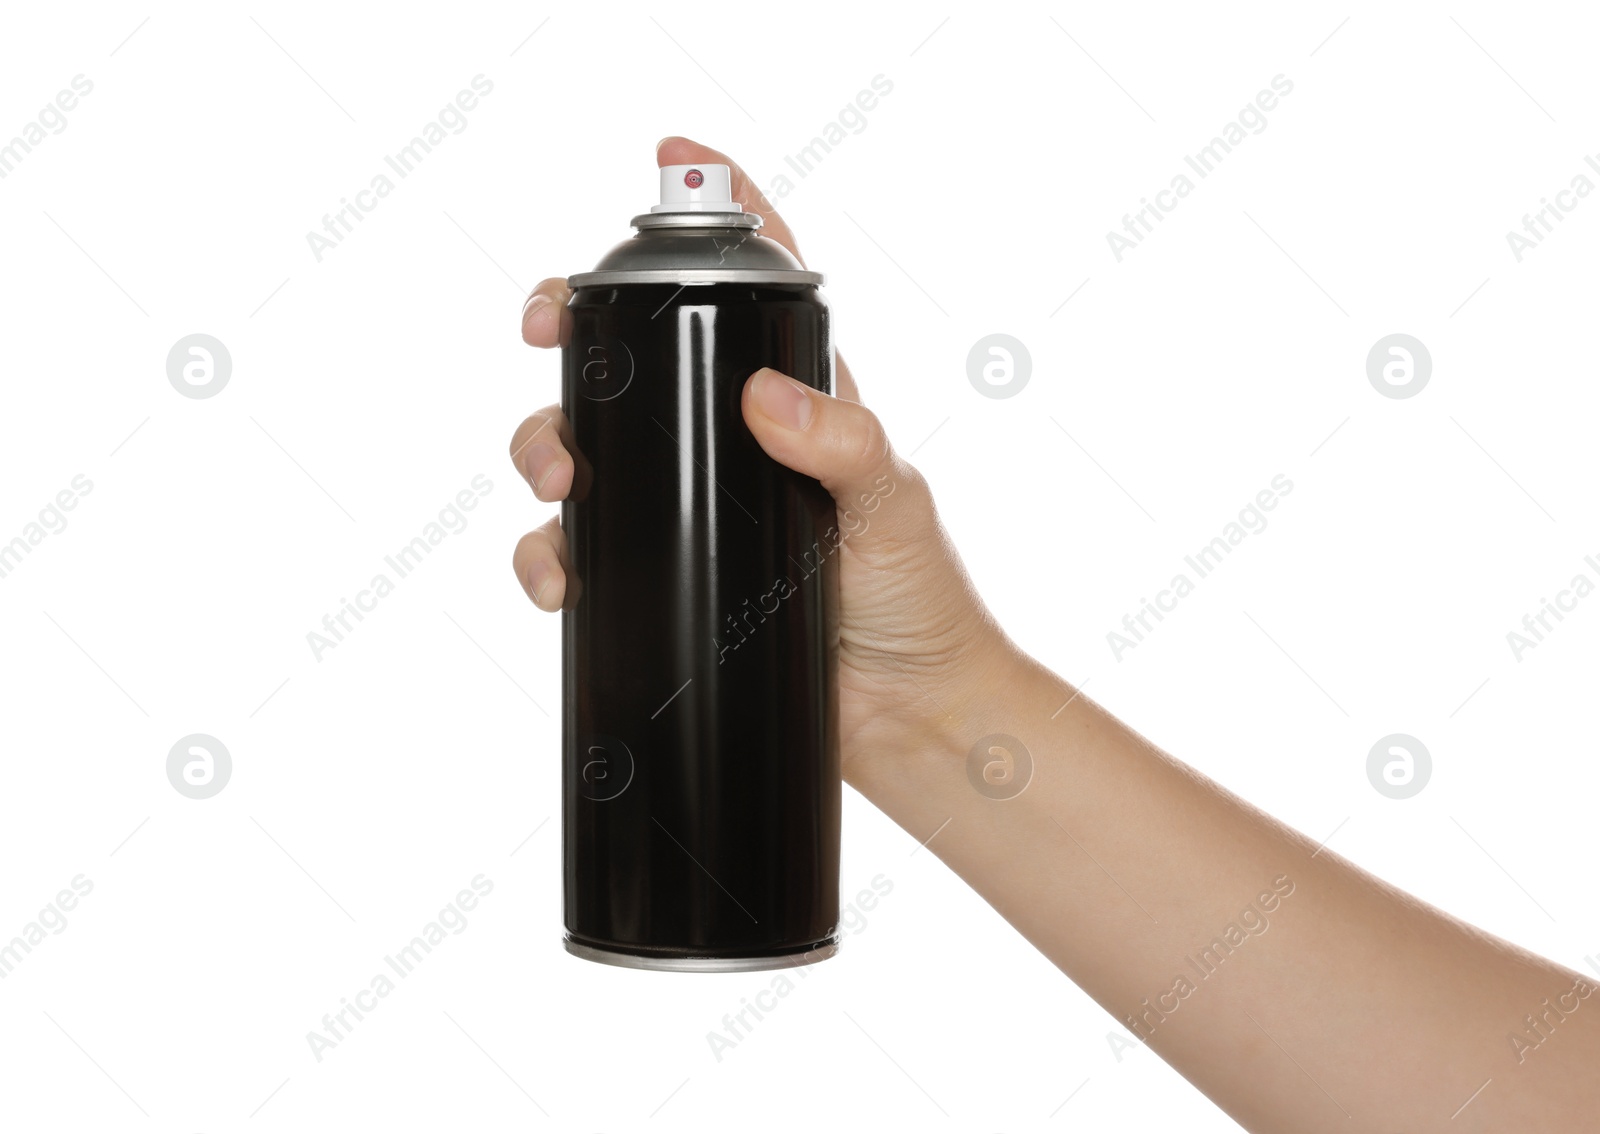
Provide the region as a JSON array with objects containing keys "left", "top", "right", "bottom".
[{"left": 562, "top": 165, "right": 840, "bottom": 972}]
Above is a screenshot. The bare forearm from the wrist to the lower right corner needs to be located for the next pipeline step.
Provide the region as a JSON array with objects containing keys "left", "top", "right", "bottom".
[{"left": 850, "top": 649, "right": 1600, "bottom": 1132}]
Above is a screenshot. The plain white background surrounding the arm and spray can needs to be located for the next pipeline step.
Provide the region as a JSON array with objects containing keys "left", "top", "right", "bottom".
[{"left": 0, "top": 3, "right": 1600, "bottom": 1131}]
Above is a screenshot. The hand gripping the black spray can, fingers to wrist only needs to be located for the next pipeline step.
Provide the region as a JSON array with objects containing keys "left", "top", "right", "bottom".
[{"left": 510, "top": 138, "right": 1014, "bottom": 782}]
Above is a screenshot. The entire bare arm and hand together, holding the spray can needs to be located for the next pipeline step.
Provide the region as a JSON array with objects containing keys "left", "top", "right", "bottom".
[{"left": 510, "top": 138, "right": 1600, "bottom": 1134}]
